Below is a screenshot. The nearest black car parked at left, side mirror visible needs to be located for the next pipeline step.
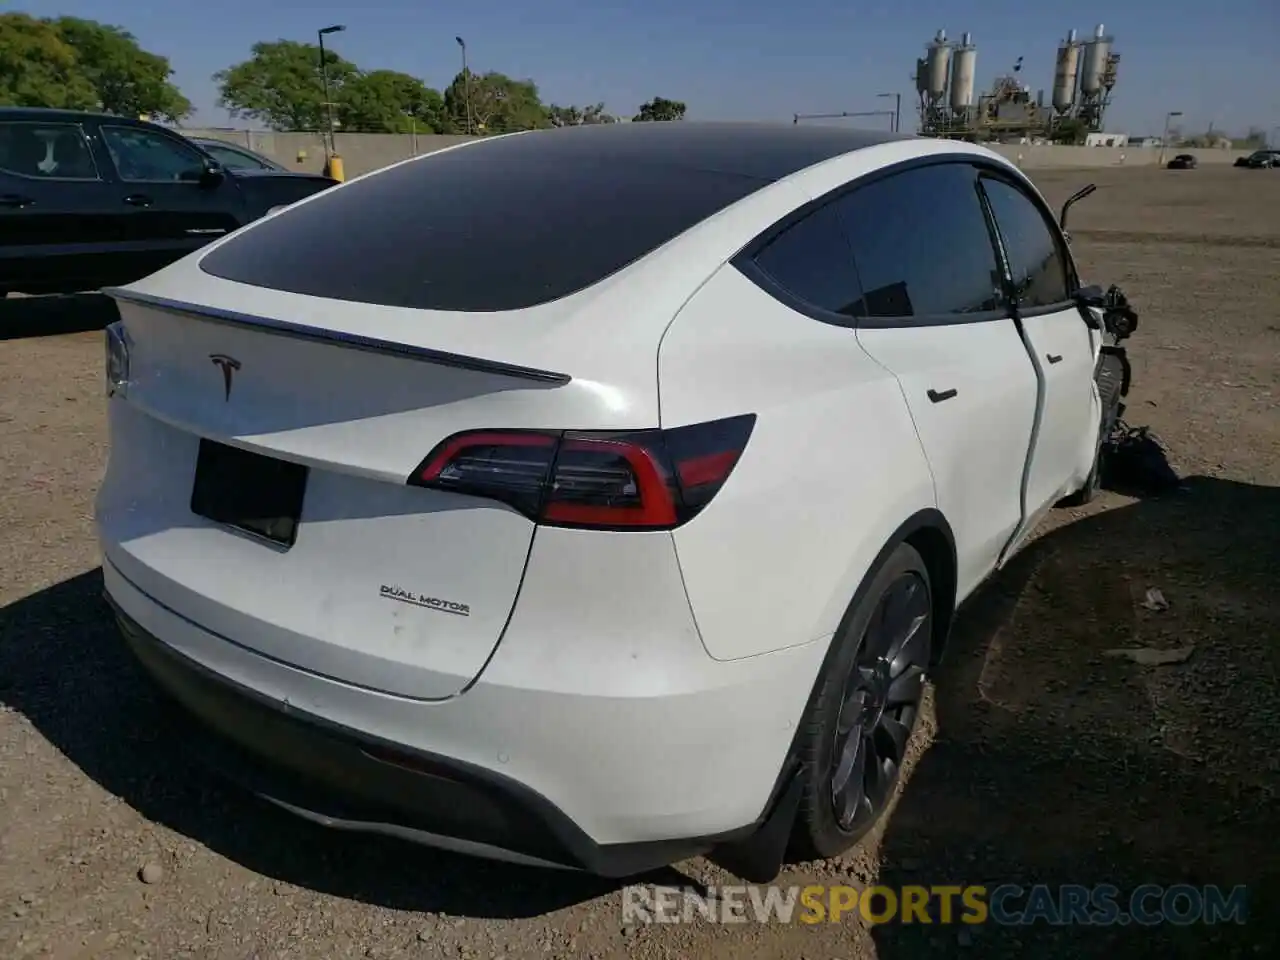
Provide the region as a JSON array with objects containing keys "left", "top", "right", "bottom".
[{"left": 0, "top": 108, "right": 337, "bottom": 294}]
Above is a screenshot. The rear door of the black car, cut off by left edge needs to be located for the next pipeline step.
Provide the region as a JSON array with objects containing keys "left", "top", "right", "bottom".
[{"left": 0, "top": 120, "right": 119, "bottom": 292}]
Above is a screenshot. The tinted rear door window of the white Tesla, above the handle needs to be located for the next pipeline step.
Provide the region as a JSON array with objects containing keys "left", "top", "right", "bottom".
[{"left": 837, "top": 164, "right": 1001, "bottom": 319}]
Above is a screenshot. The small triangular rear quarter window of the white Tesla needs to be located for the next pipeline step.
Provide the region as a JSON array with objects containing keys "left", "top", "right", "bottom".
[{"left": 755, "top": 205, "right": 861, "bottom": 316}]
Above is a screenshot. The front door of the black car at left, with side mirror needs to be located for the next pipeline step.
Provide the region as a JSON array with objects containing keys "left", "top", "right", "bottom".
[{"left": 99, "top": 123, "right": 246, "bottom": 274}]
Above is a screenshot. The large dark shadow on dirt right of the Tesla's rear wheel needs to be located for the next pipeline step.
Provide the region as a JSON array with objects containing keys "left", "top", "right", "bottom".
[{"left": 873, "top": 477, "right": 1280, "bottom": 960}]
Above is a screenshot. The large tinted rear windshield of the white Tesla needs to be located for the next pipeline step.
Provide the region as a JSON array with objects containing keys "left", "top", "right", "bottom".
[{"left": 201, "top": 132, "right": 768, "bottom": 312}]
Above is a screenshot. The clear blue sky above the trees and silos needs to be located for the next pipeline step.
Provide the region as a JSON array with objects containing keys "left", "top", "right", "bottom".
[{"left": 13, "top": 0, "right": 1280, "bottom": 134}]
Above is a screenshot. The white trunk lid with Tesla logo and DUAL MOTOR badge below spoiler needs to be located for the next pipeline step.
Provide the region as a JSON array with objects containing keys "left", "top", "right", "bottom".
[{"left": 99, "top": 284, "right": 662, "bottom": 699}]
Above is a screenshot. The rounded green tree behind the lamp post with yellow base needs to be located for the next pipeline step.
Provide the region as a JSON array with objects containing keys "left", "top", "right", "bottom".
[{"left": 214, "top": 40, "right": 358, "bottom": 131}]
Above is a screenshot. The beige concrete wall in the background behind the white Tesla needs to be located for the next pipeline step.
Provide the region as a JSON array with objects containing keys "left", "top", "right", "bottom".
[{"left": 183, "top": 129, "right": 1249, "bottom": 178}]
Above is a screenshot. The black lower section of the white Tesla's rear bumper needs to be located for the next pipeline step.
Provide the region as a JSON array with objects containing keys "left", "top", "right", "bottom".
[{"left": 109, "top": 598, "right": 755, "bottom": 877}]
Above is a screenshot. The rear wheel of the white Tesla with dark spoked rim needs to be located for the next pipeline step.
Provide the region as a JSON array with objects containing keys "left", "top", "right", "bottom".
[{"left": 788, "top": 544, "right": 933, "bottom": 860}]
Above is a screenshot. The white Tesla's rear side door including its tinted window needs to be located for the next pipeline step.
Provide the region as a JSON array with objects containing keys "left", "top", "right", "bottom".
[{"left": 838, "top": 161, "right": 1037, "bottom": 599}]
